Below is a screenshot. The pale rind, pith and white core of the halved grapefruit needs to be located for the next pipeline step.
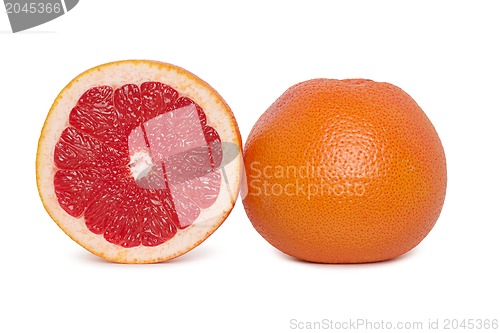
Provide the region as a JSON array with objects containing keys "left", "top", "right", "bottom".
[{"left": 37, "top": 61, "right": 242, "bottom": 263}]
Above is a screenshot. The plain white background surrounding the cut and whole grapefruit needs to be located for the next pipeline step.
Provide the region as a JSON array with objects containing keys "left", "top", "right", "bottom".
[{"left": 0, "top": 0, "right": 500, "bottom": 332}]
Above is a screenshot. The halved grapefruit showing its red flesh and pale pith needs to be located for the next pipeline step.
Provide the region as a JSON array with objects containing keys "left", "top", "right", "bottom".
[{"left": 36, "top": 60, "right": 242, "bottom": 263}]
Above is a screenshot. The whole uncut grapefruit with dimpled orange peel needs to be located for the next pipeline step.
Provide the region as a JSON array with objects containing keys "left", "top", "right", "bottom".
[{"left": 243, "top": 79, "right": 447, "bottom": 263}]
